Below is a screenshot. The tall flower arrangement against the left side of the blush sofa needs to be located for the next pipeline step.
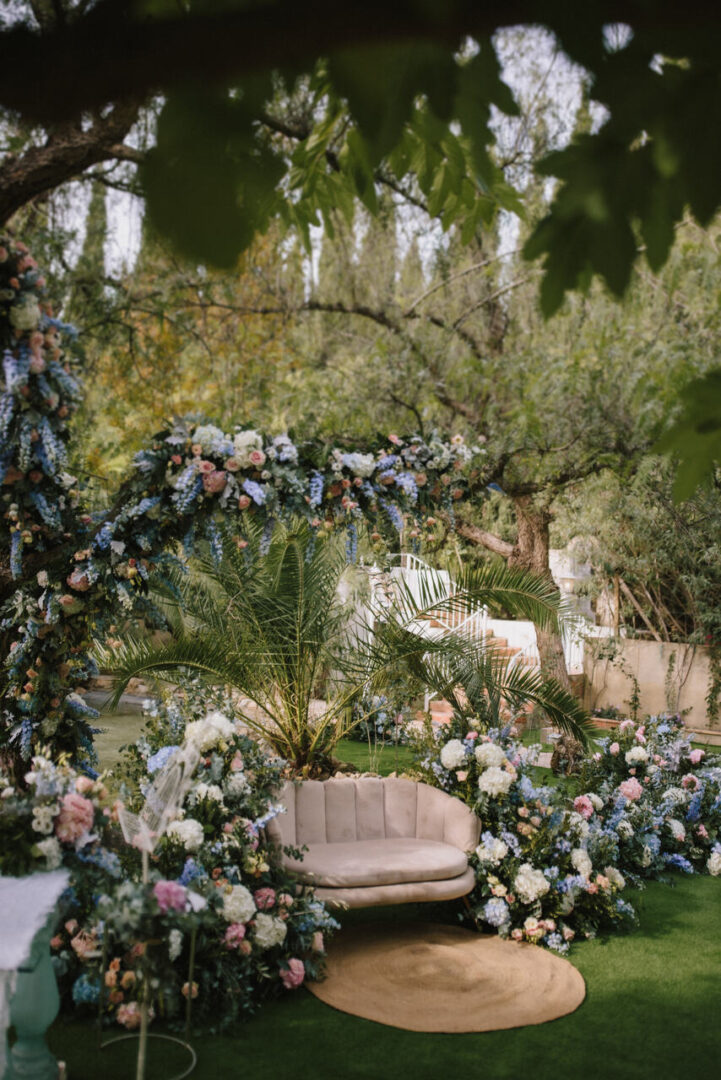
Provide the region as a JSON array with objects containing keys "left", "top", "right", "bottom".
[{"left": 78, "top": 683, "right": 337, "bottom": 1030}]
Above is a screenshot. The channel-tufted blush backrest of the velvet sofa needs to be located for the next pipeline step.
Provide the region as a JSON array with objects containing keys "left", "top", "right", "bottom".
[{"left": 267, "top": 777, "right": 480, "bottom": 851}]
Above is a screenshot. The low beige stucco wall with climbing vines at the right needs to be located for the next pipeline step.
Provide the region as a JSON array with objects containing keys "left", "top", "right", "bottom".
[{"left": 584, "top": 639, "right": 721, "bottom": 730}]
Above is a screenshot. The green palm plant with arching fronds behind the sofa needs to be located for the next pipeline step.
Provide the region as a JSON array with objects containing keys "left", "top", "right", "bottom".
[{"left": 100, "top": 524, "right": 587, "bottom": 774}]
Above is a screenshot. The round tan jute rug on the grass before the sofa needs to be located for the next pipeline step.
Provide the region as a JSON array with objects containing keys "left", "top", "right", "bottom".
[{"left": 307, "top": 922, "right": 586, "bottom": 1032}]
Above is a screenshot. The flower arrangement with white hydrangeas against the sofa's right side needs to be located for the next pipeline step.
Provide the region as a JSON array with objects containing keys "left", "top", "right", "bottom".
[{"left": 420, "top": 718, "right": 634, "bottom": 954}]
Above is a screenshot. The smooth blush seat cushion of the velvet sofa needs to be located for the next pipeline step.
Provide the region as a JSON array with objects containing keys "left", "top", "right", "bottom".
[{"left": 284, "top": 837, "right": 468, "bottom": 889}]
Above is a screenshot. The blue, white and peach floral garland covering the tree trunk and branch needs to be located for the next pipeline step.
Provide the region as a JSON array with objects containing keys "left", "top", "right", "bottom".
[{"left": 0, "top": 236, "right": 485, "bottom": 762}]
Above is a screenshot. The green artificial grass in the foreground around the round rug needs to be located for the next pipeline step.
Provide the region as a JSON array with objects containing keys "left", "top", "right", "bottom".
[{"left": 49, "top": 877, "right": 721, "bottom": 1080}]
